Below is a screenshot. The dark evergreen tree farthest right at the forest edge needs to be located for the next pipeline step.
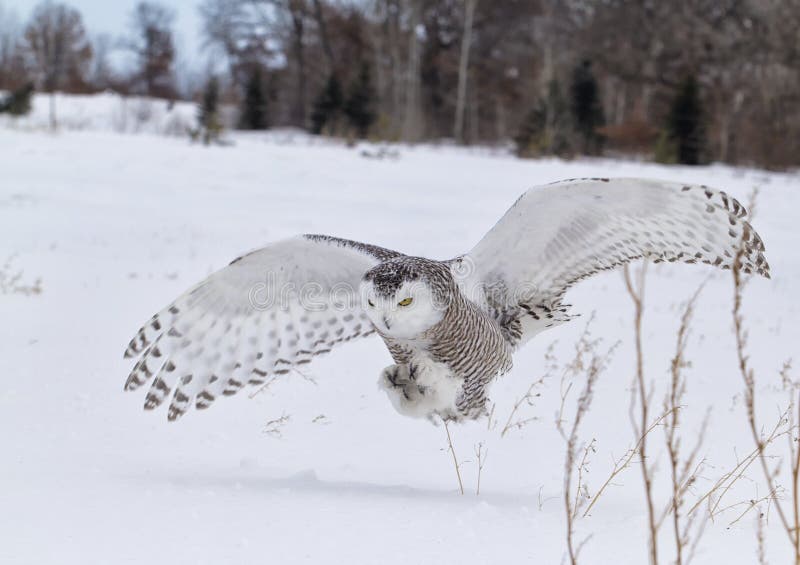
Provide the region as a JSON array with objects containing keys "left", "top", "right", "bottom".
[{"left": 667, "top": 76, "right": 705, "bottom": 165}]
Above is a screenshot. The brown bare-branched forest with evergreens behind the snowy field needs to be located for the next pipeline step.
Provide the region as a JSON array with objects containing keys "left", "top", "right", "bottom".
[{"left": 0, "top": 0, "right": 800, "bottom": 168}]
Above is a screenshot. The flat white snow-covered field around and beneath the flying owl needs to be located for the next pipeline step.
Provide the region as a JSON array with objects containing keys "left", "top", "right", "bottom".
[{"left": 0, "top": 97, "right": 800, "bottom": 565}]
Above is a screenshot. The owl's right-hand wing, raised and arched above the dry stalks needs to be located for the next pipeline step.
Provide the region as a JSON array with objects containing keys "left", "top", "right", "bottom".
[{"left": 462, "top": 178, "right": 769, "bottom": 345}]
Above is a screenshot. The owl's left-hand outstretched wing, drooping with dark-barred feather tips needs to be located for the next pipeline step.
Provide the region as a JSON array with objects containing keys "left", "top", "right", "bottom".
[{"left": 125, "top": 235, "right": 401, "bottom": 420}]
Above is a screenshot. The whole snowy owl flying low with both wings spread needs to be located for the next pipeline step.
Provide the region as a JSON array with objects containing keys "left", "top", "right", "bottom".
[{"left": 125, "top": 178, "right": 769, "bottom": 420}]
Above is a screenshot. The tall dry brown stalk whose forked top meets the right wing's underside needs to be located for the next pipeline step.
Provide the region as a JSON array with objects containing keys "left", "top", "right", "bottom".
[{"left": 624, "top": 262, "right": 658, "bottom": 565}]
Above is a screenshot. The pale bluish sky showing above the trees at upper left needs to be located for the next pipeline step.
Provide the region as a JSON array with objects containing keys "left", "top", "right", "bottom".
[{"left": 0, "top": 0, "right": 206, "bottom": 59}]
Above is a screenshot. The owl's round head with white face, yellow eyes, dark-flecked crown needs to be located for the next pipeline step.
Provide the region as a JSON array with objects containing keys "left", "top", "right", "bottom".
[{"left": 361, "top": 257, "right": 455, "bottom": 339}]
